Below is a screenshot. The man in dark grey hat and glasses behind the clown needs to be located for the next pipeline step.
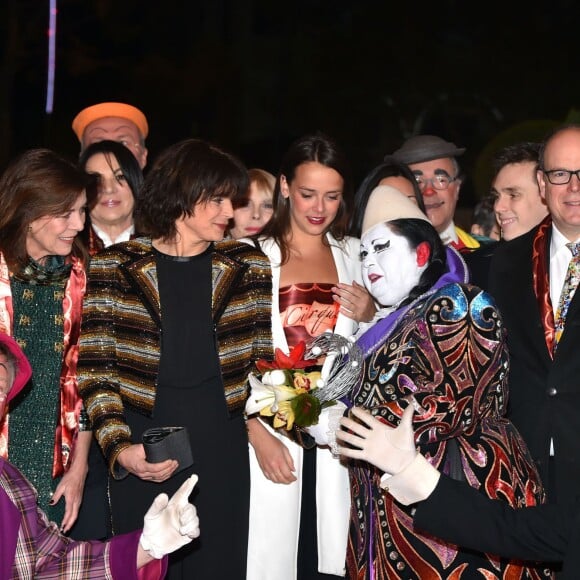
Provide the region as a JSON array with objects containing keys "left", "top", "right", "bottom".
[{"left": 392, "top": 135, "right": 480, "bottom": 252}]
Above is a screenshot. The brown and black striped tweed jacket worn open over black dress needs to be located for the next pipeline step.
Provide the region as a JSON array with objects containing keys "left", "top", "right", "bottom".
[{"left": 78, "top": 238, "right": 273, "bottom": 478}]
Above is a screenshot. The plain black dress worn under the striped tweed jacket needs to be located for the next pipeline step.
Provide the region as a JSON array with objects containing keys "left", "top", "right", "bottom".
[{"left": 110, "top": 246, "right": 250, "bottom": 580}]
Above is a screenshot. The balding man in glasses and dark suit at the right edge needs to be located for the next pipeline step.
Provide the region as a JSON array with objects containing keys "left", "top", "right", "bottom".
[{"left": 489, "top": 125, "right": 580, "bottom": 503}]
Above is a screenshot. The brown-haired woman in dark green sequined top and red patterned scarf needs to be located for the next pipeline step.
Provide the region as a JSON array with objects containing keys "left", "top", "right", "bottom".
[{"left": 0, "top": 149, "right": 91, "bottom": 532}]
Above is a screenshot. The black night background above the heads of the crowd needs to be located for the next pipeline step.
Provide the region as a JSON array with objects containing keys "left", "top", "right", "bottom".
[{"left": 0, "top": 0, "right": 580, "bottom": 218}]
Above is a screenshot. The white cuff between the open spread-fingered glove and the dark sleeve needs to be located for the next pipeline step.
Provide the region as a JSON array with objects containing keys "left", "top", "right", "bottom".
[{"left": 381, "top": 453, "right": 441, "bottom": 505}]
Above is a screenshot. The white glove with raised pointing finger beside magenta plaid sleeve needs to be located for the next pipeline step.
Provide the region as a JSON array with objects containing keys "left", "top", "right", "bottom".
[{"left": 139, "top": 473, "right": 199, "bottom": 560}]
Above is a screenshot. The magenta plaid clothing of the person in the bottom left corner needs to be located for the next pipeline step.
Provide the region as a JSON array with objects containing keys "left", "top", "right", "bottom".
[{"left": 0, "top": 459, "right": 167, "bottom": 580}]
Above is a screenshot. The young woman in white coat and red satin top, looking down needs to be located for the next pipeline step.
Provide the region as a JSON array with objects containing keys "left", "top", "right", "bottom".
[{"left": 246, "top": 134, "right": 375, "bottom": 580}]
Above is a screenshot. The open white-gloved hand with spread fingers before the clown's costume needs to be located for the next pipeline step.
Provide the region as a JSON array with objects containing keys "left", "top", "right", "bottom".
[{"left": 336, "top": 404, "right": 417, "bottom": 474}]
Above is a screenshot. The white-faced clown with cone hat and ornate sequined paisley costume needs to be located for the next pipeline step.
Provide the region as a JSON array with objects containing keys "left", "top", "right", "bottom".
[{"left": 329, "top": 186, "right": 549, "bottom": 579}]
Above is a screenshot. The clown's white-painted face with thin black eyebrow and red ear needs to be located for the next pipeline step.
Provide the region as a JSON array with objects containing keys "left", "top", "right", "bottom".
[{"left": 360, "top": 223, "right": 427, "bottom": 306}]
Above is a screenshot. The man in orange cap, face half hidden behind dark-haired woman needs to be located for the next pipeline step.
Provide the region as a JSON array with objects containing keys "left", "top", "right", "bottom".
[{"left": 72, "top": 102, "right": 149, "bottom": 169}]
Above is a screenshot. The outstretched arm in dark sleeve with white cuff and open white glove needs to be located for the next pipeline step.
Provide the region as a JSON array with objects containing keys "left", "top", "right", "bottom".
[{"left": 336, "top": 405, "right": 580, "bottom": 579}]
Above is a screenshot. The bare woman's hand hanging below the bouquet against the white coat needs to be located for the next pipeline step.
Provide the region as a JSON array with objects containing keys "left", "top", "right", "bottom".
[{"left": 248, "top": 418, "right": 296, "bottom": 483}]
